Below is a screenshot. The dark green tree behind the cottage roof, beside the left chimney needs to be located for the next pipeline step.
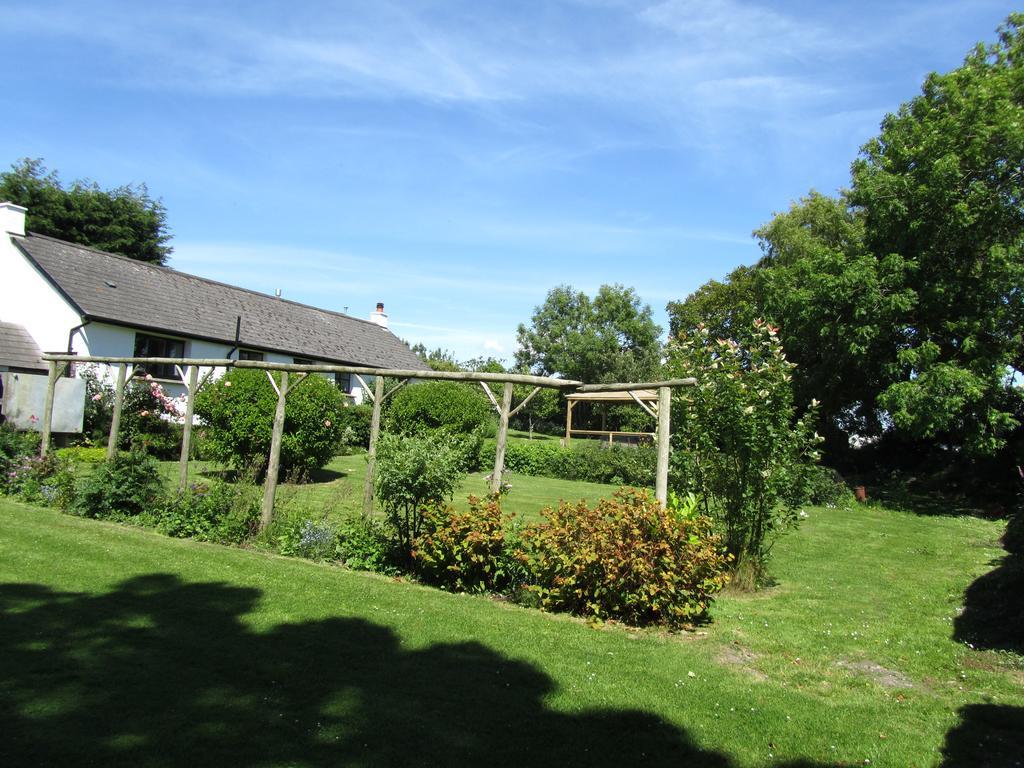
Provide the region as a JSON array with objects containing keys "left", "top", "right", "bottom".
[{"left": 0, "top": 158, "right": 171, "bottom": 264}]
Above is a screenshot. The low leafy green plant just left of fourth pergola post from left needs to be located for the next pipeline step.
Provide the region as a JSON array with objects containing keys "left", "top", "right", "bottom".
[{"left": 157, "top": 477, "right": 261, "bottom": 544}]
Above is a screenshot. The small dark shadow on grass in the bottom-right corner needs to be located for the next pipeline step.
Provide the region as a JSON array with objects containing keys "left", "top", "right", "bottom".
[{"left": 941, "top": 705, "right": 1024, "bottom": 768}]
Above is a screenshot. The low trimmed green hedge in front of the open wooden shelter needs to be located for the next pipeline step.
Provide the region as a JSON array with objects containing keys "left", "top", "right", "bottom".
[{"left": 480, "top": 440, "right": 657, "bottom": 487}]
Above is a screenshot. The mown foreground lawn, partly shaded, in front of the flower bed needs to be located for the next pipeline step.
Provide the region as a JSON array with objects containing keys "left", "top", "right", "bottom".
[{"left": 0, "top": 490, "right": 1024, "bottom": 768}]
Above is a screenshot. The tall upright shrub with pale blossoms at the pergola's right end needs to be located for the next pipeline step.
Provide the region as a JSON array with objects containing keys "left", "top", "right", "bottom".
[{"left": 669, "top": 321, "right": 821, "bottom": 588}]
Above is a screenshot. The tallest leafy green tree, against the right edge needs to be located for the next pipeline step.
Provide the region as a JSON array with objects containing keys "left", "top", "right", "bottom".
[{"left": 850, "top": 14, "right": 1024, "bottom": 453}]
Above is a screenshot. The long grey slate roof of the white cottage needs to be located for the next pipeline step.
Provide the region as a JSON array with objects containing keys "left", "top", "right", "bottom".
[{"left": 13, "top": 232, "right": 427, "bottom": 370}]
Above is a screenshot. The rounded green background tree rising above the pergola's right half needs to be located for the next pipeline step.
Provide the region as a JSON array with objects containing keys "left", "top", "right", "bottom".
[{"left": 515, "top": 285, "right": 662, "bottom": 383}]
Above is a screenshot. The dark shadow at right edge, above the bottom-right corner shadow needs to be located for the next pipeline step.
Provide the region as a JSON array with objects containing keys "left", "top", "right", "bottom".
[{"left": 953, "top": 512, "right": 1024, "bottom": 653}]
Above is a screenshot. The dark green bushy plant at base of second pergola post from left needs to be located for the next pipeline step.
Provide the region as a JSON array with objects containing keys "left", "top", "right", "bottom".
[{"left": 73, "top": 451, "right": 164, "bottom": 518}]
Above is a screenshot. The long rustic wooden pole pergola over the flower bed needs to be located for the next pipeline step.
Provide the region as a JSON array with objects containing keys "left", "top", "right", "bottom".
[{"left": 39, "top": 353, "right": 696, "bottom": 528}]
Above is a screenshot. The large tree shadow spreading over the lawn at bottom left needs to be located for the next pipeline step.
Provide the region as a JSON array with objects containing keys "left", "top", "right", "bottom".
[{"left": 0, "top": 574, "right": 823, "bottom": 768}]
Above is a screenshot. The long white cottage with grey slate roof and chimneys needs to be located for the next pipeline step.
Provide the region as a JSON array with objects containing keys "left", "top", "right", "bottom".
[{"left": 0, "top": 203, "right": 426, "bottom": 399}]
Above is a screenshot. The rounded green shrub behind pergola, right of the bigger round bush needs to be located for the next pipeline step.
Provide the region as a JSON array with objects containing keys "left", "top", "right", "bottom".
[{"left": 387, "top": 381, "right": 490, "bottom": 434}]
